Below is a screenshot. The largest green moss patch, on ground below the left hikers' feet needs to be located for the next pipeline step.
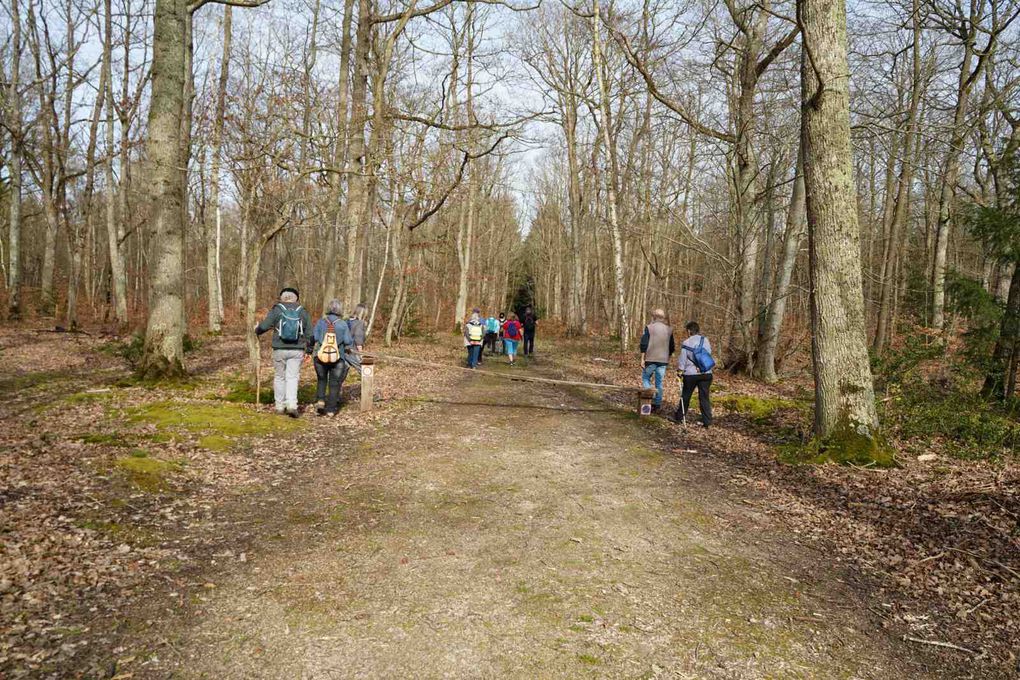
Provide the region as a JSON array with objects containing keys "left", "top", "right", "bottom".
[{"left": 128, "top": 401, "right": 302, "bottom": 451}]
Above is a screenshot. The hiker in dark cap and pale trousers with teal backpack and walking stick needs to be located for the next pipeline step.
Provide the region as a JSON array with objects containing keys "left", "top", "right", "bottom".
[{"left": 255, "top": 287, "right": 313, "bottom": 418}]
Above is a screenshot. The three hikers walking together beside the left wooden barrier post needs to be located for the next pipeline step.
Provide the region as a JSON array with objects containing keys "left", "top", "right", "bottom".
[{"left": 255, "top": 287, "right": 368, "bottom": 418}]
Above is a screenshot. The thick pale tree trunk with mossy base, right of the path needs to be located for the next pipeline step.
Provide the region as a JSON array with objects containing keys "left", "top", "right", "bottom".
[{"left": 799, "top": 0, "right": 878, "bottom": 453}]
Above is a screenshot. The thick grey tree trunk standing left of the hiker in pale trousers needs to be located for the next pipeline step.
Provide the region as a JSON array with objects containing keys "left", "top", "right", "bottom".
[{"left": 140, "top": 0, "right": 190, "bottom": 379}]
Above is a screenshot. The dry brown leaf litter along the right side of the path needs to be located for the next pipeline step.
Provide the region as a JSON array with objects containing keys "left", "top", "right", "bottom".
[{"left": 538, "top": 344, "right": 1020, "bottom": 677}]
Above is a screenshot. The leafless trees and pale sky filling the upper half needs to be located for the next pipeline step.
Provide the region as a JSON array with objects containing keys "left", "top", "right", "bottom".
[{"left": 0, "top": 0, "right": 1020, "bottom": 422}]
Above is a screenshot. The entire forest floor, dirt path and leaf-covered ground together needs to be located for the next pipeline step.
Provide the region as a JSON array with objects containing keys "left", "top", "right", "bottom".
[{"left": 0, "top": 332, "right": 1016, "bottom": 678}]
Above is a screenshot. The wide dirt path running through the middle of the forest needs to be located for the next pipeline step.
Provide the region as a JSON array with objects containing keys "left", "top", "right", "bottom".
[{"left": 148, "top": 369, "right": 924, "bottom": 678}]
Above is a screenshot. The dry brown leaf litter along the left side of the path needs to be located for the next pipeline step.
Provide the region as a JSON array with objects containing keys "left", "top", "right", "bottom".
[{"left": 0, "top": 327, "right": 460, "bottom": 678}]
